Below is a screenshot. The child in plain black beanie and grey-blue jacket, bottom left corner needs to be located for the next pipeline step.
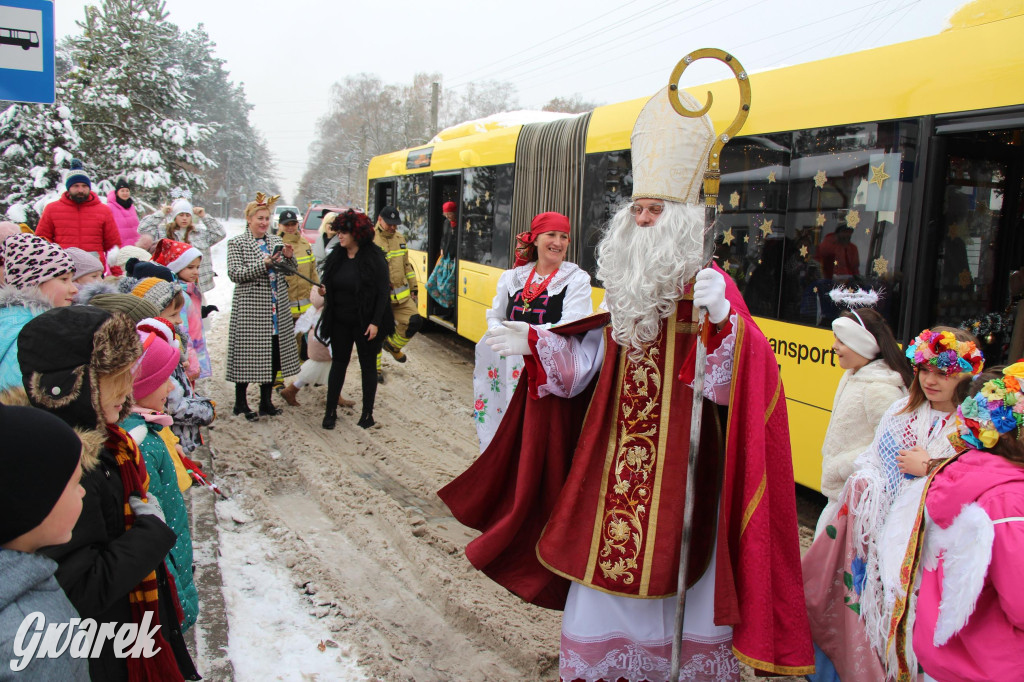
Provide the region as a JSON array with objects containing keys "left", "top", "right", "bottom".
[{"left": 0, "top": 407, "right": 89, "bottom": 682}]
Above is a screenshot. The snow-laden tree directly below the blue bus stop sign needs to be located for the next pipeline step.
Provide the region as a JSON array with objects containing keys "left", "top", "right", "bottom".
[{"left": 0, "top": 71, "right": 82, "bottom": 225}]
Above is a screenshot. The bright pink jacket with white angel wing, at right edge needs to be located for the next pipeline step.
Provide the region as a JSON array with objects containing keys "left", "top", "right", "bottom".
[{"left": 913, "top": 450, "right": 1024, "bottom": 682}]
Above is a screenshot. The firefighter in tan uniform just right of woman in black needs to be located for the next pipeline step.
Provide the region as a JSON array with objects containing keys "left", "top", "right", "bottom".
[{"left": 374, "top": 206, "right": 423, "bottom": 383}]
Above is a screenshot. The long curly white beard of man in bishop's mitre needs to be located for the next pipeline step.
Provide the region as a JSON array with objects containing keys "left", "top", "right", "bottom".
[{"left": 597, "top": 202, "right": 705, "bottom": 361}]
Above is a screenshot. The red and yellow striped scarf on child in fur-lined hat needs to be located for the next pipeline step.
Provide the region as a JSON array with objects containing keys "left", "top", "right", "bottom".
[{"left": 106, "top": 424, "right": 184, "bottom": 682}]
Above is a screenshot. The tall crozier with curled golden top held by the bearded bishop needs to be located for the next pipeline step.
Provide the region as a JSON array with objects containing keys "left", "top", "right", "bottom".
[{"left": 669, "top": 47, "right": 751, "bottom": 682}]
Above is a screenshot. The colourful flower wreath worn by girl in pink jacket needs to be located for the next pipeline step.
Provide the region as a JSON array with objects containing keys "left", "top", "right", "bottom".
[{"left": 949, "top": 361, "right": 1024, "bottom": 451}]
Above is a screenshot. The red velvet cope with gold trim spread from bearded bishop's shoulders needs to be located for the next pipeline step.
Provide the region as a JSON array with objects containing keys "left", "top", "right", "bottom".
[{"left": 438, "top": 268, "right": 814, "bottom": 675}]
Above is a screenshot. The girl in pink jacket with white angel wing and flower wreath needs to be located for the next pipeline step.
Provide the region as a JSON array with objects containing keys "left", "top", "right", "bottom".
[{"left": 895, "top": 363, "right": 1024, "bottom": 682}]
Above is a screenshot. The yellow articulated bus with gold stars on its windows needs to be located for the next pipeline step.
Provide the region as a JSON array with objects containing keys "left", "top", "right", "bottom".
[{"left": 367, "top": 11, "right": 1024, "bottom": 489}]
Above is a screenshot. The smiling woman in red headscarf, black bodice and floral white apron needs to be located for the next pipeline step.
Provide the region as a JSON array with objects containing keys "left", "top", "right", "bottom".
[{"left": 473, "top": 211, "right": 594, "bottom": 453}]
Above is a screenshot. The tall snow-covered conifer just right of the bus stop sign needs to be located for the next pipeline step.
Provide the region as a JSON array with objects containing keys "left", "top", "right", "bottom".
[{"left": 65, "top": 0, "right": 215, "bottom": 200}]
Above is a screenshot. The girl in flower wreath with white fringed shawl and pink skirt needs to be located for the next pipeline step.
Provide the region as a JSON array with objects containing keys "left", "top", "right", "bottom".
[{"left": 802, "top": 327, "right": 984, "bottom": 682}]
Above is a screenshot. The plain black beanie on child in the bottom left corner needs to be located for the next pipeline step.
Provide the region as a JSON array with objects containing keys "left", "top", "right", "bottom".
[{"left": 0, "top": 406, "right": 82, "bottom": 545}]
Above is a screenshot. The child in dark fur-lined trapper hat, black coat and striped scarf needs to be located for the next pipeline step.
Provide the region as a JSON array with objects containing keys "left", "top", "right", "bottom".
[{"left": 18, "top": 305, "right": 198, "bottom": 680}]
